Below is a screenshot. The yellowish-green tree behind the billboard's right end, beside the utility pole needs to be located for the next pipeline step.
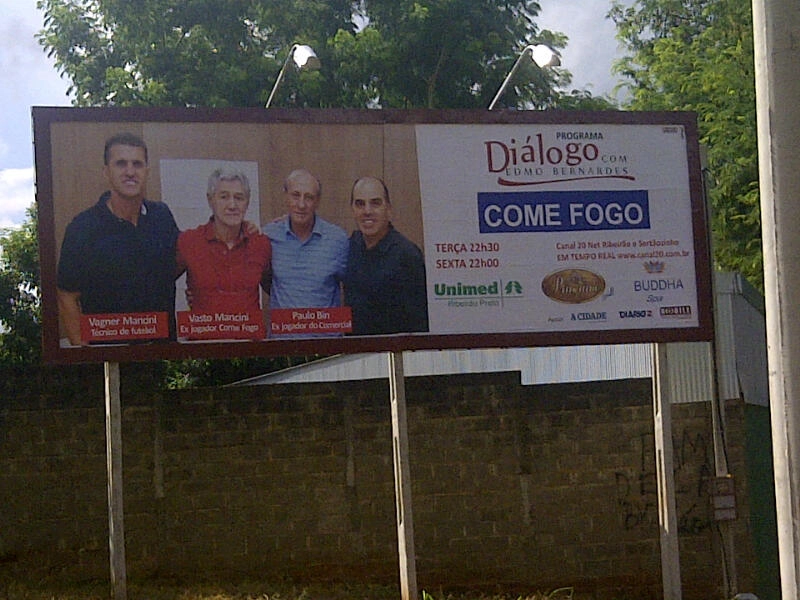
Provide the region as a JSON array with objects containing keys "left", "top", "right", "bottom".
[{"left": 609, "top": 0, "right": 763, "bottom": 289}]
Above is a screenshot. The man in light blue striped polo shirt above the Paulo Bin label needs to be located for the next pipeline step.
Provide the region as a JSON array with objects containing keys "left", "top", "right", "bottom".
[{"left": 263, "top": 169, "right": 348, "bottom": 309}]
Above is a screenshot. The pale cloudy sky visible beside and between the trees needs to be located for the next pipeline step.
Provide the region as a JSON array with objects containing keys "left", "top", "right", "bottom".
[{"left": 0, "top": 0, "right": 632, "bottom": 228}]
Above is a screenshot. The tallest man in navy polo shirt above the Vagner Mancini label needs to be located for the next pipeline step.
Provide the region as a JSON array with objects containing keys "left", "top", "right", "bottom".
[{"left": 57, "top": 133, "right": 178, "bottom": 345}]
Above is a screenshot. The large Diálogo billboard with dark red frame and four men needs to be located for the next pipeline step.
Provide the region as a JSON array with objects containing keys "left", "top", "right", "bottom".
[{"left": 33, "top": 107, "right": 712, "bottom": 362}]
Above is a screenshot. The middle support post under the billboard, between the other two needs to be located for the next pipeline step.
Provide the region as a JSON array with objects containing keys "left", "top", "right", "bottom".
[{"left": 388, "top": 352, "right": 417, "bottom": 600}]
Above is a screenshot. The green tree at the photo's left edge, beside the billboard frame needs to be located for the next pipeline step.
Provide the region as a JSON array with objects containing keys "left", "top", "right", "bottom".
[{"left": 0, "top": 205, "right": 41, "bottom": 365}]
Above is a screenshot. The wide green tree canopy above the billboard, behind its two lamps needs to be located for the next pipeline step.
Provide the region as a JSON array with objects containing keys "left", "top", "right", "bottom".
[{"left": 37, "top": 0, "right": 592, "bottom": 108}]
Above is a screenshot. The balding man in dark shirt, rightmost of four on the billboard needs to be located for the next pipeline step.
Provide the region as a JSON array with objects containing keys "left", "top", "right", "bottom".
[{"left": 344, "top": 177, "right": 428, "bottom": 335}]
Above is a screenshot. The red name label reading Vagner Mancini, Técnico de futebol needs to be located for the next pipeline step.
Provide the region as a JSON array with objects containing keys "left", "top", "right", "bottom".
[{"left": 81, "top": 312, "right": 169, "bottom": 344}]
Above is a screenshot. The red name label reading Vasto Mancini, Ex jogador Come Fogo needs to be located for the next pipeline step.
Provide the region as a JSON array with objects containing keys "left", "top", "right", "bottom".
[{"left": 177, "top": 310, "right": 267, "bottom": 340}]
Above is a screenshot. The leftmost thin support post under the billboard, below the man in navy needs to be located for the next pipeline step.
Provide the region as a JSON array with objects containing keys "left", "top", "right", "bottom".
[{"left": 104, "top": 362, "right": 128, "bottom": 600}]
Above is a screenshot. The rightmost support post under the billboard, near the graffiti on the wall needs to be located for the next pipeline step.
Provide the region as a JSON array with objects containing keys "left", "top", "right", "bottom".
[{"left": 652, "top": 344, "right": 681, "bottom": 600}]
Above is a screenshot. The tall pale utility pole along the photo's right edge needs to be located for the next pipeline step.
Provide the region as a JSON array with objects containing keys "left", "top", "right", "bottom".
[{"left": 753, "top": 0, "right": 800, "bottom": 600}]
